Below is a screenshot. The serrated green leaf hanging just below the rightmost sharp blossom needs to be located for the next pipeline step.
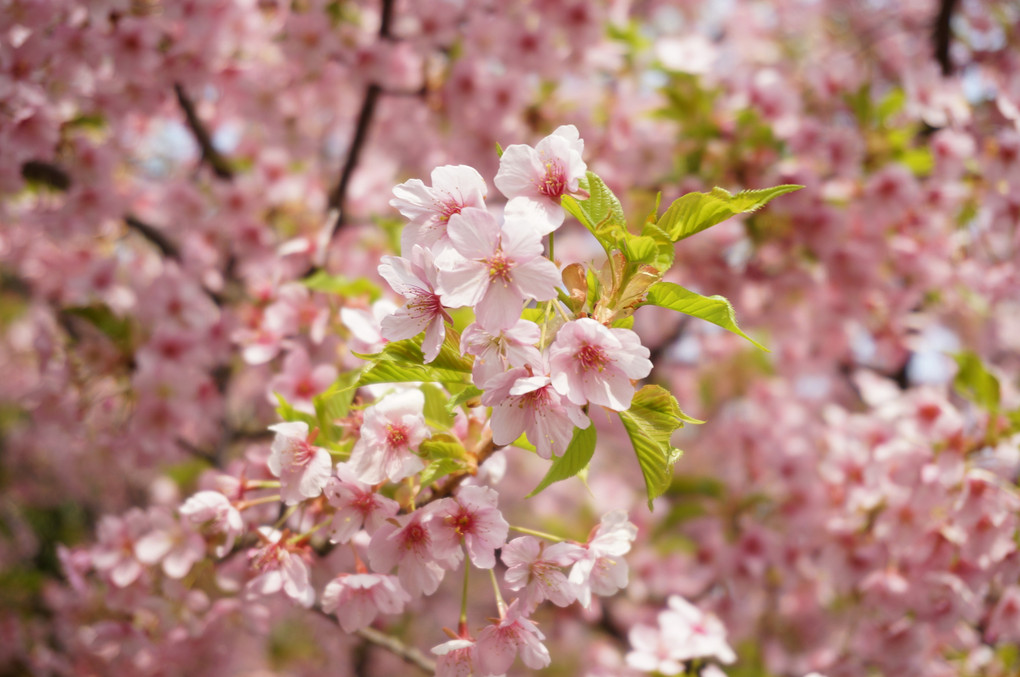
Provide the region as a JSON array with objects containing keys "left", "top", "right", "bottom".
[{"left": 620, "top": 385, "right": 689, "bottom": 510}]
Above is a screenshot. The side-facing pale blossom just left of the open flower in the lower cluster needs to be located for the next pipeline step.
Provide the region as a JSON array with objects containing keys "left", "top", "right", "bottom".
[{"left": 267, "top": 421, "right": 333, "bottom": 506}]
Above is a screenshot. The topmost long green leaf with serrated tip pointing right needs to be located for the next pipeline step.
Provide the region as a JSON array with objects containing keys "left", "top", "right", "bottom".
[{"left": 657, "top": 185, "right": 804, "bottom": 242}]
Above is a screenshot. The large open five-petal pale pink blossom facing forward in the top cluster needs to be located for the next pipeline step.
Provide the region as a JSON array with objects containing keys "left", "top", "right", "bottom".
[{"left": 437, "top": 208, "right": 560, "bottom": 332}]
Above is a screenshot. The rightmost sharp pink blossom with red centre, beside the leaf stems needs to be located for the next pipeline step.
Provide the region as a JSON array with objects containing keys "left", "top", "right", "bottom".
[{"left": 549, "top": 317, "right": 652, "bottom": 411}]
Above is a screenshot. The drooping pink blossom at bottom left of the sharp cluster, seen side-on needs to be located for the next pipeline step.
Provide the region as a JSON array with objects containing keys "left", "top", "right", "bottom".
[{"left": 322, "top": 574, "right": 411, "bottom": 632}]
